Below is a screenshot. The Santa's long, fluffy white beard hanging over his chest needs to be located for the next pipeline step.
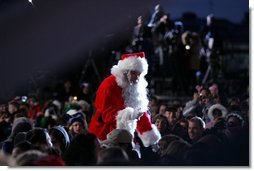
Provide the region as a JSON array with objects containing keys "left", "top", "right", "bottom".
[{"left": 123, "top": 78, "right": 148, "bottom": 112}]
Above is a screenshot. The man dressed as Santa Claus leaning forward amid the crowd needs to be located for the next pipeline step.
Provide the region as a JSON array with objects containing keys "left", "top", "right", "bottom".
[{"left": 89, "top": 52, "right": 161, "bottom": 147}]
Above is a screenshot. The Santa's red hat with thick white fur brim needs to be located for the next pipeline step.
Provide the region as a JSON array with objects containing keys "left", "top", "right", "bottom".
[{"left": 111, "top": 52, "right": 148, "bottom": 75}]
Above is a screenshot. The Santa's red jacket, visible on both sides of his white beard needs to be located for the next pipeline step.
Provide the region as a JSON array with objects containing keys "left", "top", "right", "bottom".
[{"left": 88, "top": 75, "right": 160, "bottom": 146}]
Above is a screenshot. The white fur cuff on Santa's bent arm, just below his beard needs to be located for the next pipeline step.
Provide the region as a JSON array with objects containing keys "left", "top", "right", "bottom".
[{"left": 116, "top": 107, "right": 137, "bottom": 137}]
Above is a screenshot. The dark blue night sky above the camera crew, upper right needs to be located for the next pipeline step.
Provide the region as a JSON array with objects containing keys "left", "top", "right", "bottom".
[{"left": 161, "top": 0, "right": 249, "bottom": 23}]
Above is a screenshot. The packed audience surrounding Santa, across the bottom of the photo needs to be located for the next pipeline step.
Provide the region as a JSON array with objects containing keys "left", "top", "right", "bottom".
[{"left": 0, "top": 78, "right": 249, "bottom": 166}]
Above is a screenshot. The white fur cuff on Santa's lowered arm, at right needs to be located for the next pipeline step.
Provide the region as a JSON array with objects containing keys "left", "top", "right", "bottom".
[{"left": 138, "top": 124, "right": 161, "bottom": 147}]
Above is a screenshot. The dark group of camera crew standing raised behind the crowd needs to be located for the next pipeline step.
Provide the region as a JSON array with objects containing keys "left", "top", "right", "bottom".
[{"left": 126, "top": 4, "right": 245, "bottom": 96}]
